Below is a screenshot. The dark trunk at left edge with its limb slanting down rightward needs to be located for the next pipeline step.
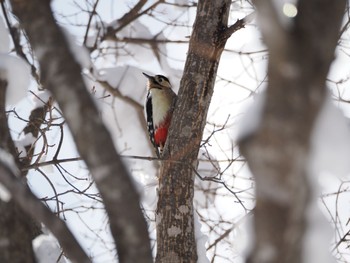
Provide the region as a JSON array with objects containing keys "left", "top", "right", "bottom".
[{"left": 0, "top": 79, "right": 85, "bottom": 263}]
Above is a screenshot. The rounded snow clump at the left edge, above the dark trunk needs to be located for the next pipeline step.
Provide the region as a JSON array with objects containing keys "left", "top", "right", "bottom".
[{"left": 0, "top": 53, "right": 30, "bottom": 105}]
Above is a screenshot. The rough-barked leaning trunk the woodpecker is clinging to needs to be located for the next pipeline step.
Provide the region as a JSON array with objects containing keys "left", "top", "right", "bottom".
[{"left": 156, "top": 0, "right": 231, "bottom": 263}]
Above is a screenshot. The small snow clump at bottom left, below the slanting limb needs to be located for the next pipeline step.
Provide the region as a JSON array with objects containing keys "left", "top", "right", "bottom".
[{"left": 32, "top": 235, "right": 67, "bottom": 263}]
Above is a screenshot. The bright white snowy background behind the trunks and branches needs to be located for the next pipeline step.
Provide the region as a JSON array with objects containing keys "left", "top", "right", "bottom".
[{"left": 0, "top": 0, "right": 350, "bottom": 263}]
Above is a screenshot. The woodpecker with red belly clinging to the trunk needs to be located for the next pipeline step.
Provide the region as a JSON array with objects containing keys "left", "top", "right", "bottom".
[{"left": 142, "top": 73, "right": 177, "bottom": 158}]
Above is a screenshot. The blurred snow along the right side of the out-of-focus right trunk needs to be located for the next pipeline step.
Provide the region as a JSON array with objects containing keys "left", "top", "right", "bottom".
[{"left": 303, "top": 95, "right": 350, "bottom": 263}]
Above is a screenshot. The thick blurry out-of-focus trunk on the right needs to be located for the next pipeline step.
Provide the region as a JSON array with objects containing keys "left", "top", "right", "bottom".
[{"left": 240, "top": 0, "right": 345, "bottom": 263}]
